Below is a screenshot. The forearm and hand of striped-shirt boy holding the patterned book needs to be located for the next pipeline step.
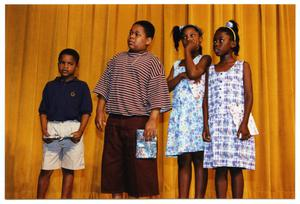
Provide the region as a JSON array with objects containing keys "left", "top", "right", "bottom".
[{"left": 144, "top": 108, "right": 160, "bottom": 140}]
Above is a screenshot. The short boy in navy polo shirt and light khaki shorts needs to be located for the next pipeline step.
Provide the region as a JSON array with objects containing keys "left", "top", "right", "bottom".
[{"left": 37, "top": 49, "right": 92, "bottom": 198}]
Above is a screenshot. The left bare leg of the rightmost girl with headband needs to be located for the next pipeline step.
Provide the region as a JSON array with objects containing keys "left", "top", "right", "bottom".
[{"left": 215, "top": 167, "right": 228, "bottom": 198}]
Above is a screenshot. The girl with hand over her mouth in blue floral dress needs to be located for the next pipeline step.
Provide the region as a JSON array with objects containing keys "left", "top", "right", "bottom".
[{"left": 166, "top": 25, "right": 211, "bottom": 198}]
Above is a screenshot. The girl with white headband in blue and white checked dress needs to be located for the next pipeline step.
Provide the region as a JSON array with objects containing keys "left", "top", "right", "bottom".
[{"left": 203, "top": 20, "right": 255, "bottom": 198}]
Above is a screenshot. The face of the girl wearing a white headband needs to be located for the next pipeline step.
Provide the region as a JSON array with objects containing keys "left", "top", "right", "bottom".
[{"left": 213, "top": 31, "right": 234, "bottom": 56}]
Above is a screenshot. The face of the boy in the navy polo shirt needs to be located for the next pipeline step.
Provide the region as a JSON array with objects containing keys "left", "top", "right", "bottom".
[{"left": 58, "top": 55, "right": 77, "bottom": 78}]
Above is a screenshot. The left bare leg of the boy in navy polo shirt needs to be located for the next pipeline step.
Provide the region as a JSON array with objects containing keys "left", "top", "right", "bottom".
[{"left": 37, "top": 170, "right": 53, "bottom": 199}]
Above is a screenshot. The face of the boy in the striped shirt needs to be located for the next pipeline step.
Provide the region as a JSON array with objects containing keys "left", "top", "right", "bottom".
[{"left": 127, "top": 24, "right": 152, "bottom": 52}]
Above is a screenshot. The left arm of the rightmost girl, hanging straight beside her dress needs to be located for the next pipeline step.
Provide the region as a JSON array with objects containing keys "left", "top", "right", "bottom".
[{"left": 202, "top": 69, "right": 210, "bottom": 142}]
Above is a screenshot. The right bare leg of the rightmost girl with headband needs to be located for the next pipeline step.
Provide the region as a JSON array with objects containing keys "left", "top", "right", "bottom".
[{"left": 230, "top": 168, "right": 244, "bottom": 198}]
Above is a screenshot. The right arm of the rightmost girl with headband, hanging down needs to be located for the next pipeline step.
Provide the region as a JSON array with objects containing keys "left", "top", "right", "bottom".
[{"left": 237, "top": 62, "right": 253, "bottom": 140}]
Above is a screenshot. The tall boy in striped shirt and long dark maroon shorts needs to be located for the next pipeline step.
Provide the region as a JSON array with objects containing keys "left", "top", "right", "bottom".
[{"left": 94, "top": 21, "right": 171, "bottom": 198}]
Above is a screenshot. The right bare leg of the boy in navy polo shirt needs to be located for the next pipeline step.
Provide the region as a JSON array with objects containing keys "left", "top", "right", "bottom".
[{"left": 61, "top": 168, "right": 74, "bottom": 198}]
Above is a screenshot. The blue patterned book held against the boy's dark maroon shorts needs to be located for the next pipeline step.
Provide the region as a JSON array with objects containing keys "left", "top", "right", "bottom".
[{"left": 136, "top": 129, "right": 157, "bottom": 159}]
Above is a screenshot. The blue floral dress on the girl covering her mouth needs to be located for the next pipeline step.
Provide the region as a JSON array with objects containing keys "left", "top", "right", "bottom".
[{"left": 166, "top": 55, "right": 205, "bottom": 156}]
